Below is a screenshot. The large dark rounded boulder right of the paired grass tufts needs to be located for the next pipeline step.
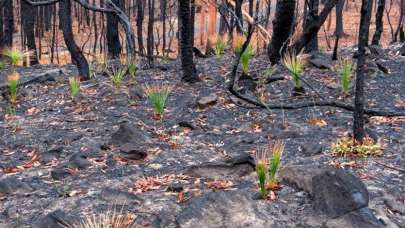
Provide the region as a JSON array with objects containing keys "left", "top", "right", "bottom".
[{"left": 312, "top": 169, "right": 369, "bottom": 218}]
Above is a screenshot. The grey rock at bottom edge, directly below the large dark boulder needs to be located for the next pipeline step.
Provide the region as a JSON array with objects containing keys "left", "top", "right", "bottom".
[{"left": 325, "top": 207, "right": 385, "bottom": 228}]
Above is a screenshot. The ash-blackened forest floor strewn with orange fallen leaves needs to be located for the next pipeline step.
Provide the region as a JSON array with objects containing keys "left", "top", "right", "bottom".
[{"left": 0, "top": 45, "right": 405, "bottom": 227}]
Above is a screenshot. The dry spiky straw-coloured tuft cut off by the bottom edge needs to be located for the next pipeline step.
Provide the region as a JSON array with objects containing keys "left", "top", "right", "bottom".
[{"left": 66, "top": 209, "right": 136, "bottom": 228}]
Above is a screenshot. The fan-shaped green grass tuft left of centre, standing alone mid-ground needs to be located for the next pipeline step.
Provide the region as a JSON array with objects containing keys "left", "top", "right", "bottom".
[{"left": 143, "top": 84, "right": 173, "bottom": 119}]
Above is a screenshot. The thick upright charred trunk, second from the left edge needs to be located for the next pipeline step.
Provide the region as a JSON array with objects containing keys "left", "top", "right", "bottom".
[{"left": 20, "top": 1, "right": 38, "bottom": 65}]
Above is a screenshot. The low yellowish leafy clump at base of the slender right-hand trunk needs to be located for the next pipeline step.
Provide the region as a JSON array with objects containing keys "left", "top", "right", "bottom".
[{"left": 331, "top": 136, "right": 383, "bottom": 157}]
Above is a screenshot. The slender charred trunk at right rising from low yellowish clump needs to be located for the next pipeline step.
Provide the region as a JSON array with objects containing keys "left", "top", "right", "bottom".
[{"left": 353, "top": 0, "right": 373, "bottom": 143}]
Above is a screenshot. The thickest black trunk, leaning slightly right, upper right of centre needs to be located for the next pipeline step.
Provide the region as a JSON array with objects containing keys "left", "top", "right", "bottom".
[{"left": 268, "top": 0, "right": 296, "bottom": 64}]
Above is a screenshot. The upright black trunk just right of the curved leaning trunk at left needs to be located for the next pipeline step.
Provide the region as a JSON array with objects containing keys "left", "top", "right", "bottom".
[{"left": 107, "top": 0, "right": 122, "bottom": 59}]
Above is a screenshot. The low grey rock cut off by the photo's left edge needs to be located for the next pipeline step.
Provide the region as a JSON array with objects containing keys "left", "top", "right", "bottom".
[{"left": 0, "top": 177, "right": 33, "bottom": 196}]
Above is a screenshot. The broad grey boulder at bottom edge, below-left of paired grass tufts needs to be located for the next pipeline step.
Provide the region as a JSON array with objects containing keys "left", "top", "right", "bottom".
[{"left": 176, "top": 191, "right": 274, "bottom": 228}]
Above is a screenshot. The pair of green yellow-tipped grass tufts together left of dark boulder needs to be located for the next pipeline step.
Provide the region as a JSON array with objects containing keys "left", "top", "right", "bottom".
[{"left": 256, "top": 141, "right": 285, "bottom": 199}]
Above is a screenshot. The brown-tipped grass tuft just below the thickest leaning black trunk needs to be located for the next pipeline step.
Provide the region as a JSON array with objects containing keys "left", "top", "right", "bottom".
[{"left": 282, "top": 51, "right": 304, "bottom": 90}]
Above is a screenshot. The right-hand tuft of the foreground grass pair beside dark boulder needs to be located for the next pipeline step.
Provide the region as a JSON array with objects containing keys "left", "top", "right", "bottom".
[{"left": 268, "top": 140, "right": 285, "bottom": 189}]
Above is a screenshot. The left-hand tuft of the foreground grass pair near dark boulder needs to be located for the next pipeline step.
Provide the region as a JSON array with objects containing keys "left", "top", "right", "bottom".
[{"left": 256, "top": 149, "right": 268, "bottom": 199}]
